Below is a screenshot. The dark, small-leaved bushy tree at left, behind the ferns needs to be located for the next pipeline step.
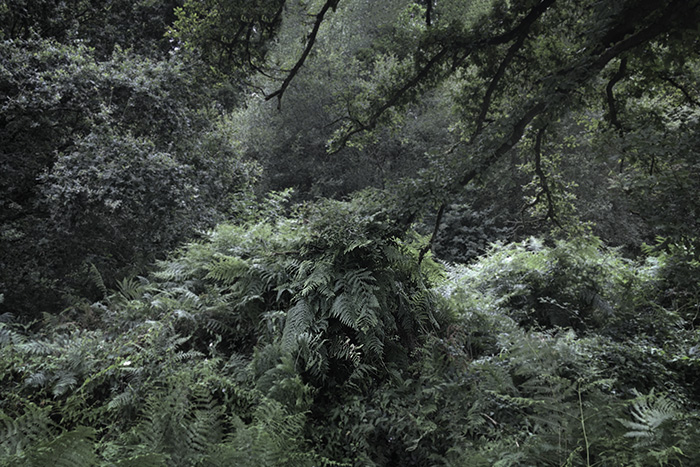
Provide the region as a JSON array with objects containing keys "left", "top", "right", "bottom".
[{"left": 0, "top": 39, "right": 257, "bottom": 318}]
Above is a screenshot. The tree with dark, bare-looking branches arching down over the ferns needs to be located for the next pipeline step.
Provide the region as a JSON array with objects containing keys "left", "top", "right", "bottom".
[{"left": 183, "top": 0, "right": 699, "bottom": 254}]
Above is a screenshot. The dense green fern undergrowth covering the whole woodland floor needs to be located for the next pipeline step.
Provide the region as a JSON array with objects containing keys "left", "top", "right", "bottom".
[{"left": 0, "top": 193, "right": 700, "bottom": 466}]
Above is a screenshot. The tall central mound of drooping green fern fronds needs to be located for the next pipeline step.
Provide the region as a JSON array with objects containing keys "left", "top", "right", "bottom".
[{"left": 159, "top": 194, "right": 440, "bottom": 380}]
